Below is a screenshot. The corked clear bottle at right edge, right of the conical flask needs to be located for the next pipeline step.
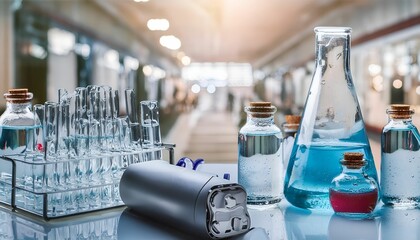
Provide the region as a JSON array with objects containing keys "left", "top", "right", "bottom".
[{"left": 381, "top": 104, "right": 420, "bottom": 208}]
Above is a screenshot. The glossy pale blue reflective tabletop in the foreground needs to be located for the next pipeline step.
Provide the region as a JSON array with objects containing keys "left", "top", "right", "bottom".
[{"left": 0, "top": 201, "right": 420, "bottom": 240}]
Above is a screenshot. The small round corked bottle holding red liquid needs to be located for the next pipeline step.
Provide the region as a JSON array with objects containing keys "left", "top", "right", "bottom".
[{"left": 329, "top": 152, "right": 378, "bottom": 218}]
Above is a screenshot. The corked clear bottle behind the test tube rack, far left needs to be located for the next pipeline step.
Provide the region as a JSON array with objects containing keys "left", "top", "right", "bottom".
[{"left": 0, "top": 88, "right": 41, "bottom": 156}]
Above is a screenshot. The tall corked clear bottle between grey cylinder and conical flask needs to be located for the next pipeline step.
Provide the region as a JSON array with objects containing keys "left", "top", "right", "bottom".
[{"left": 238, "top": 102, "right": 283, "bottom": 205}]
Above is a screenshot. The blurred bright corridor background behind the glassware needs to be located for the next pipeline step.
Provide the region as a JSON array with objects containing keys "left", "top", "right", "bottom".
[{"left": 0, "top": 0, "right": 420, "bottom": 166}]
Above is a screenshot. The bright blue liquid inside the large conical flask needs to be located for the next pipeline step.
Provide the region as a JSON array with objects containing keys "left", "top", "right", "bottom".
[{"left": 285, "top": 126, "right": 377, "bottom": 209}]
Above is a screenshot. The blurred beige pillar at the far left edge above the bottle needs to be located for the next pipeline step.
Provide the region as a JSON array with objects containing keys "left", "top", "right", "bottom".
[{"left": 0, "top": 0, "right": 14, "bottom": 108}]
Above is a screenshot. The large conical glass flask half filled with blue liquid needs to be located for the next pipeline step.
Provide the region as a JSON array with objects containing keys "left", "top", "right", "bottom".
[{"left": 284, "top": 27, "right": 378, "bottom": 209}]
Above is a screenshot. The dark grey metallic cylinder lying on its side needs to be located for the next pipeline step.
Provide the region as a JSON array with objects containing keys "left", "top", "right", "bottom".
[{"left": 120, "top": 160, "right": 251, "bottom": 239}]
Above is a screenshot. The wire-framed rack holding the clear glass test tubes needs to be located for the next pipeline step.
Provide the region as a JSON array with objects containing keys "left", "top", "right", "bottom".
[{"left": 0, "top": 144, "right": 175, "bottom": 220}]
